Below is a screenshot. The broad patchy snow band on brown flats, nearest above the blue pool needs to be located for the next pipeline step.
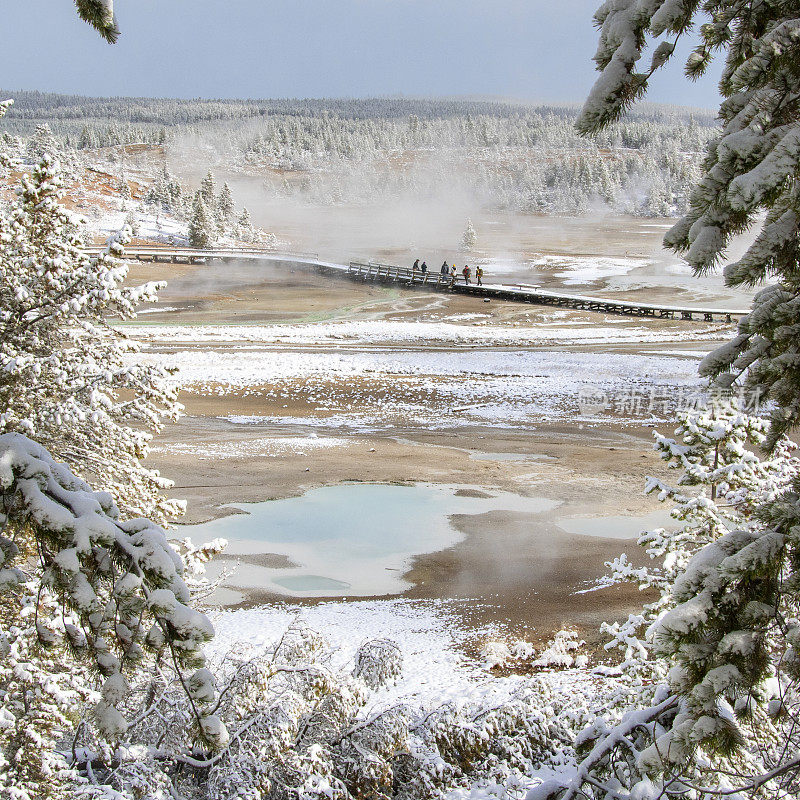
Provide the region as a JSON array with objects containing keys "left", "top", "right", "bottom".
[{"left": 145, "top": 349, "right": 702, "bottom": 427}]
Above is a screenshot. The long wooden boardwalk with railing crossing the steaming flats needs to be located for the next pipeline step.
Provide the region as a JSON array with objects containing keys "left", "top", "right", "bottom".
[{"left": 86, "top": 245, "right": 749, "bottom": 322}]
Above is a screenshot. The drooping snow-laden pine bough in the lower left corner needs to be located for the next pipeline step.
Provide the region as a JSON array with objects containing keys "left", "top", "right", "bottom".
[{"left": 0, "top": 433, "right": 227, "bottom": 747}]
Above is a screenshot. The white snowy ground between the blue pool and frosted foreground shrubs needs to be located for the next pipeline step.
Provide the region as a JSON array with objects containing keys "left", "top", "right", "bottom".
[{"left": 208, "top": 600, "right": 621, "bottom": 800}]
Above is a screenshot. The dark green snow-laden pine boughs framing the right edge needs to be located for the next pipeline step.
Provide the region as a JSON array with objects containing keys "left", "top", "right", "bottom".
[{"left": 548, "top": 0, "right": 800, "bottom": 800}]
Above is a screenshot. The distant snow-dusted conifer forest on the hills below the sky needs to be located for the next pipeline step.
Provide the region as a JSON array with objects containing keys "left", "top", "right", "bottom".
[{"left": 0, "top": 92, "right": 716, "bottom": 217}]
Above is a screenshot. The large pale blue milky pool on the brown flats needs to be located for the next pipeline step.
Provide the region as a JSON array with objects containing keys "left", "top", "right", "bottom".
[{"left": 182, "top": 483, "right": 559, "bottom": 597}]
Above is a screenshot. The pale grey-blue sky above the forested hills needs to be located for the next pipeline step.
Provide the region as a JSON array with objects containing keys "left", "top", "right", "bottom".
[{"left": 0, "top": 0, "right": 717, "bottom": 107}]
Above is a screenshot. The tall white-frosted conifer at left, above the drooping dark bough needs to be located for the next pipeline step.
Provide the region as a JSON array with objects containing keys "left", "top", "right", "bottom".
[{"left": 0, "top": 155, "right": 180, "bottom": 518}]
